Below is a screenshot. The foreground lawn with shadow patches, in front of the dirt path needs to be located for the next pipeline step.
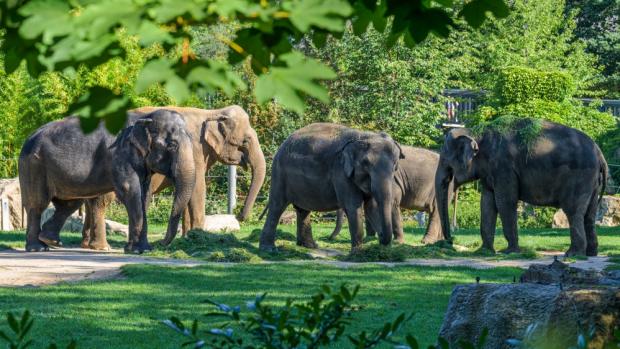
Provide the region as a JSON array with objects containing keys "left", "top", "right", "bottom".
[{"left": 0, "top": 264, "right": 520, "bottom": 348}]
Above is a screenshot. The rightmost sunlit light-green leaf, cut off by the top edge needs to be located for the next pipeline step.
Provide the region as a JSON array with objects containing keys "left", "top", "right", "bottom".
[{"left": 285, "top": 0, "right": 353, "bottom": 33}]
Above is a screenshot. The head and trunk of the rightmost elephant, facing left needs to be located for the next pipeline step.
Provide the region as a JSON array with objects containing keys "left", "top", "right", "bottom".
[{"left": 435, "top": 128, "right": 479, "bottom": 240}]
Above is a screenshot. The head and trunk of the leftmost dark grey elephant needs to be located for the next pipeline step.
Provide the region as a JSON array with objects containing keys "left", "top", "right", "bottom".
[{"left": 129, "top": 109, "right": 196, "bottom": 245}]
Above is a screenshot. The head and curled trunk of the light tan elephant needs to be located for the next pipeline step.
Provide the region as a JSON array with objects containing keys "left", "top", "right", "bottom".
[{"left": 203, "top": 106, "right": 266, "bottom": 221}]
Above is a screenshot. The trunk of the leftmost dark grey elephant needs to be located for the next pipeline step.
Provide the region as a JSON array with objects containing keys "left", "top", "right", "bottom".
[{"left": 163, "top": 139, "right": 196, "bottom": 245}]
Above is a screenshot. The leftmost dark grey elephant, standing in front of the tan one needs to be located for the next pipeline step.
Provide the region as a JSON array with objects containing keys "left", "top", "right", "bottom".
[{"left": 18, "top": 109, "right": 196, "bottom": 253}]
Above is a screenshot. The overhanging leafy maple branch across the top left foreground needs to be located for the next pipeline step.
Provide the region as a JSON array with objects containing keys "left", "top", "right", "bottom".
[{"left": 0, "top": 0, "right": 508, "bottom": 131}]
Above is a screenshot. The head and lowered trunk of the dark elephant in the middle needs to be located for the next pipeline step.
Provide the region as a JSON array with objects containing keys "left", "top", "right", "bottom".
[{"left": 342, "top": 133, "right": 404, "bottom": 245}]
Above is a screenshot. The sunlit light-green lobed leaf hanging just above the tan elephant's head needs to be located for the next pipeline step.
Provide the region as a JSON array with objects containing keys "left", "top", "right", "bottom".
[{"left": 254, "top": 52, "right": 336, "bottom": 114}]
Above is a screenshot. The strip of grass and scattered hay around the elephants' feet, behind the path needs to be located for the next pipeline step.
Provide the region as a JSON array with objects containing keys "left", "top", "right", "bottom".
[{"left": 0, "top": 223, "right": 620, "bottom": 262}]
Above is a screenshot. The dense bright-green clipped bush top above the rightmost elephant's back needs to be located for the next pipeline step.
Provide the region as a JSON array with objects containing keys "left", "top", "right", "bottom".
[{"left": 495, "top": 67, "right": 576, "bottom": 105}]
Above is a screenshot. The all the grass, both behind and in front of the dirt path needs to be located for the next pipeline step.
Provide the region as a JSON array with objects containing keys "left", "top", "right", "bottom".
[{"left": 0, "top": 223, "right": 620, "bottom": 348}]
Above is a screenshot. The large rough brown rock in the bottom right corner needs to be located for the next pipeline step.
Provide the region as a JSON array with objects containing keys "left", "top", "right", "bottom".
[{"left": 439, "top": 283, "right": 620, "bottom": 349}]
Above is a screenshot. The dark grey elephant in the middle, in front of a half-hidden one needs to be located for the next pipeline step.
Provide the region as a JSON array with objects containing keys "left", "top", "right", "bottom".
[{"left": 259, "top": 123, "right": 404, "bottom": 251}]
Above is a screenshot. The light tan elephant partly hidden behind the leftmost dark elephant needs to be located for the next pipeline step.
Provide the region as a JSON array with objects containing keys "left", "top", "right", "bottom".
[{"left": 82, "top": 105, "right": 266, "bottom": 249}]
